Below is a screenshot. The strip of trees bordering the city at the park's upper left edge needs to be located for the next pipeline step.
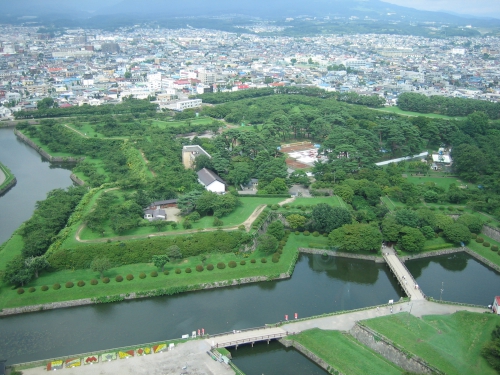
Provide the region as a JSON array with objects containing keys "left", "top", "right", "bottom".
[{"left": 14, "top": 99, "right": 158, "bottom": 120}]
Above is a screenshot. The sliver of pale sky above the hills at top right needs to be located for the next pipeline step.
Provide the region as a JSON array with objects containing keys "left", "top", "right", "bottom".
[{"left": 382, "top": 0, "right": 500, "bottom": 18}]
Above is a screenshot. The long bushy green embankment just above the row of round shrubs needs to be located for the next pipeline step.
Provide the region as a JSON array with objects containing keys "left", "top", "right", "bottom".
[{"left": 48, "top": 231, "right": 250, "bottom": 270}]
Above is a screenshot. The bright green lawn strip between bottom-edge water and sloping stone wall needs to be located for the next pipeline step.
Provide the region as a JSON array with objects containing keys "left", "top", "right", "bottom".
[{"left": 287, "top": 328, "right": 403, "bottom": 375}]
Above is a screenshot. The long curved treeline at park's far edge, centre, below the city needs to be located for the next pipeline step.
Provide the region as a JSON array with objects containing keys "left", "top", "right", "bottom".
[{"left": 196, "top": 86, "right": 385, "bottom": 108}]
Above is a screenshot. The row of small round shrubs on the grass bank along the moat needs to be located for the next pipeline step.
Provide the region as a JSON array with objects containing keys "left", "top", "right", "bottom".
[{"left": 17, "top": 258, "right": 276, "bottom": 294}]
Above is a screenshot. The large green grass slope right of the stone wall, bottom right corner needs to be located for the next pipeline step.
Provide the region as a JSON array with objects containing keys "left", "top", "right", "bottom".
[{"left": 363, "top": 311, "right": 500, "bottom": 375}]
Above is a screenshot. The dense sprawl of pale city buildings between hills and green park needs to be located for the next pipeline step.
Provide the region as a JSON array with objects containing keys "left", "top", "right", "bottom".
[{"left": 0, "top": 25, "right": 500, "bottom": 118}]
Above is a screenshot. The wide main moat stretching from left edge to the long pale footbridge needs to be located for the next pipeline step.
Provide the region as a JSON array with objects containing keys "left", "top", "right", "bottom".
[{"left": 0, "top": 255, "right": 401, "bottom": 363}]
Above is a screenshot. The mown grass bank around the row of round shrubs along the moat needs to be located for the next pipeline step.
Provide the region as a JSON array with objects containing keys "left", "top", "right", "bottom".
[{"left": 0, "top": 235, "right": 297, "bottom": 309}]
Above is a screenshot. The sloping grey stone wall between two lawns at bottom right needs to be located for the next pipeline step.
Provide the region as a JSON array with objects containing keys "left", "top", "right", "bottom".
[{"left": 349, "top": 323, "right": 444, "bottom": 374}]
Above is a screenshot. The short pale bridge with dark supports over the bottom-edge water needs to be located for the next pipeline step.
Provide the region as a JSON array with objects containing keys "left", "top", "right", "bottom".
[{"left": 206, "top": 327, "right": 288, "bottom": 349}]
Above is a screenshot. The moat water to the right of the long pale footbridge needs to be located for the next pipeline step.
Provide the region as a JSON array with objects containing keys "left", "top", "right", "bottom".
[{"left": 406, "top": 253, "right": 500, "bottom": 305}]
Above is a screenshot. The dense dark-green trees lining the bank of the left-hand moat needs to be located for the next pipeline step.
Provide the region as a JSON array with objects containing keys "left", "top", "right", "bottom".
[{"left": 4, "top": 187, "right": 86, "bottom": 285}]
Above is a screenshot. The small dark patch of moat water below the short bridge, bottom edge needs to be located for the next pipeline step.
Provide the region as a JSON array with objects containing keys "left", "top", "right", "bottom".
[{"left": 229, "top": 341, "right": 328, "bottom": 375}]
